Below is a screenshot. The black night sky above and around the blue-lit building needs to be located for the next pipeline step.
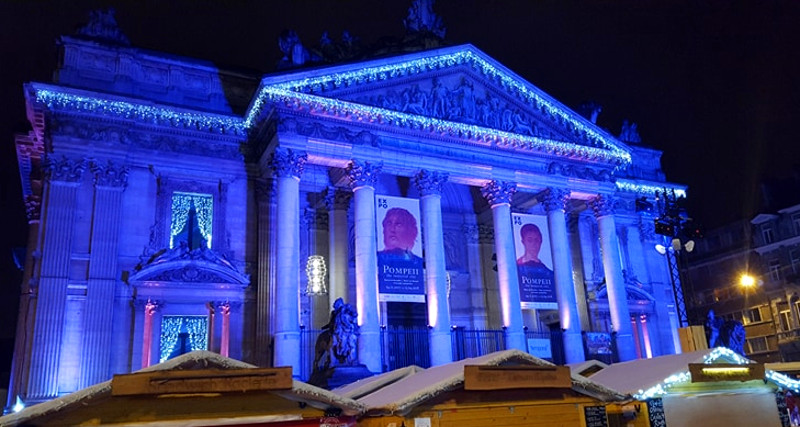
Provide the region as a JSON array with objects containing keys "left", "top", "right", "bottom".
[{"left": 0, "top": 0, "right": 800, "bottom": 362}]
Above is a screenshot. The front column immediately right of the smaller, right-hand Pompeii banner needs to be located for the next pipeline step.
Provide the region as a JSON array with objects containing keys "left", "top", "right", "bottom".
[{"left": 542, "top": 188, "right": 586, "bottom": 363}]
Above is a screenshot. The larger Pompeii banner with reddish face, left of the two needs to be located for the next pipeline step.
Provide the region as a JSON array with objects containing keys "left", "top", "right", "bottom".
[{"left": 375, "top": 195, "right": 425, "bottom": 302}]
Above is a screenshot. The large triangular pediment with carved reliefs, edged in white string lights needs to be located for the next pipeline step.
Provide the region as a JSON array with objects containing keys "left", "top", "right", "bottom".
[{"left": 245, "top": 45, "right": 631, "bottom": 165}]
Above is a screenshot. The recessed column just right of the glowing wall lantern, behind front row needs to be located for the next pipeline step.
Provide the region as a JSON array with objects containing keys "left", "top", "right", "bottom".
[{"left": 325, "top": 187, "right": 353, "bottom": 310}]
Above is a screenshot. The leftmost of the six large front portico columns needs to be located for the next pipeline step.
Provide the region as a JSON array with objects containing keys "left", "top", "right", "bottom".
[{"left": 271, "top": 148, "right": 308, "bottom": 376}]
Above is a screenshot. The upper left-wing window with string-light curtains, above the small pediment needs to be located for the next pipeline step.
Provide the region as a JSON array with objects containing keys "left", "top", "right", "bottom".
[{"left": 169, "top": 192, "right": 214, "bottom": 249}]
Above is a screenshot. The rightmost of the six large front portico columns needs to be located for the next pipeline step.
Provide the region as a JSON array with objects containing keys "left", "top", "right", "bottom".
[{"left": 590, "top": 195, "right": 636, "bottom": 362}]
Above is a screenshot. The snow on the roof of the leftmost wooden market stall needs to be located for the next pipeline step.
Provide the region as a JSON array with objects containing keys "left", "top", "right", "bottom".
[{"left": 0, "top": 351, "right": 365, "bottom": 426}]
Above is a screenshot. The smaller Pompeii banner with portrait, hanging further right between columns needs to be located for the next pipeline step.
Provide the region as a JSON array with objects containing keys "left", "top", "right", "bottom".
[{"left": 512, "top": 214, "right": 558, "bottom": 310}]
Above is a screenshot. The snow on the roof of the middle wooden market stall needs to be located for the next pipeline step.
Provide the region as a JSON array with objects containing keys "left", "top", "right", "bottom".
[{"left": 358, "top": 350, "right": 626, "bottom": 414}]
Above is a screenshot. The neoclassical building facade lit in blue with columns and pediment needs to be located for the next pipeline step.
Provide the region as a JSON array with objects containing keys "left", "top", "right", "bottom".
[{"left": 9, "top": 16, "right": 685, "bottom": 403}]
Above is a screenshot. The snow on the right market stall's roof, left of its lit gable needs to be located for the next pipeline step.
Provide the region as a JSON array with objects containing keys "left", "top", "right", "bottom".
[{"left": 592, "top": 349, "right": 712, "bottom": 394}]
